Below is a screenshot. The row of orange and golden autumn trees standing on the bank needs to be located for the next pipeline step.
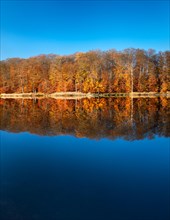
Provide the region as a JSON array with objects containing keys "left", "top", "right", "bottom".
[{"left": 0, "top": 49, "right": 170, "bottom": 93}]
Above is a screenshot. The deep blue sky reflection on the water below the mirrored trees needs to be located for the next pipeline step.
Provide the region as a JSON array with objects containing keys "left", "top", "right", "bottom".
[{"left": 1, "top": 132, "right": 170, "bottom": 220}]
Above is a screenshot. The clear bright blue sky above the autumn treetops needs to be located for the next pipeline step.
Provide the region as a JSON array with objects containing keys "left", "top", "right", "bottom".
[{"left": 1, "top": 0, "right": 170, "bottom": 59}]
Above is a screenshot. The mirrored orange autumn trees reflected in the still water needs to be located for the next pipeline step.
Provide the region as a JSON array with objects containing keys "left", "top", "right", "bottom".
[{"left": 0, "top": 98, "right": 170, "bottom": 140}]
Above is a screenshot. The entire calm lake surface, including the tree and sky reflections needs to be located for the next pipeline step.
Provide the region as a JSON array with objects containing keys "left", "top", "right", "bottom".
[{"left": 0, "top": 97, "right": 170, "bottom": 220}]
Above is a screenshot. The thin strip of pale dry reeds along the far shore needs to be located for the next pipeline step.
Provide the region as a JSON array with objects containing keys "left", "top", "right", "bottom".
[{"left": 0, "top": 92, "right": 170, "bottom": 99}]
